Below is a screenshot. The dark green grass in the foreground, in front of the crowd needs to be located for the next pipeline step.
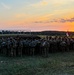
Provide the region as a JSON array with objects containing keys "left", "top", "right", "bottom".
[{"left": 0, "top": 52, "right": 74, "bottom": 75}]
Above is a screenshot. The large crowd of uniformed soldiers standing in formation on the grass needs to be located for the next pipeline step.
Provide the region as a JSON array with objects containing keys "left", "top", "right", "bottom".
[{"left": 0, "top": 36, "right": 74, "bottom": 56}]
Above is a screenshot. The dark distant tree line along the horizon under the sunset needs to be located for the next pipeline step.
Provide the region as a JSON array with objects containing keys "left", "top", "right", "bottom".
[{"left": 0, "top": 30, "right": 74, "bottom": 36}]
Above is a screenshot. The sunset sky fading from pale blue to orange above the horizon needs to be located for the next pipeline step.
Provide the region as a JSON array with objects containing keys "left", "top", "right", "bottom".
[{"left": 0, "top": 0, "right": 74, "bottom": 31}]
